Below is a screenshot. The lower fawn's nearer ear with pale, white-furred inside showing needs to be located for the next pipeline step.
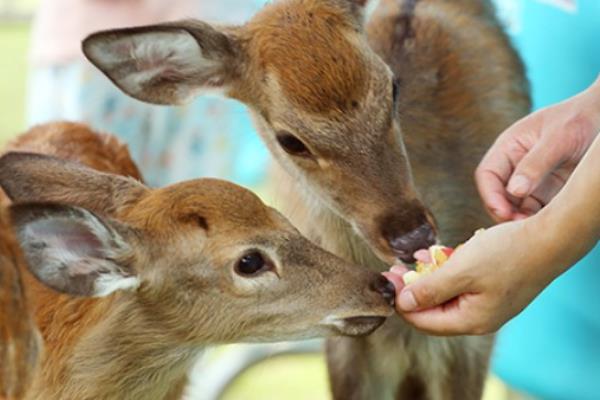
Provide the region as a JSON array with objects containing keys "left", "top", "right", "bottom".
[{"left": 10, "top": 204, "right": 139, "bottom": 297}]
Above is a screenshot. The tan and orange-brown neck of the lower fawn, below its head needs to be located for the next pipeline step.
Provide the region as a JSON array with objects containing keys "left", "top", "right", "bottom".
[{"left": 26, "top": 284, "right": 208, "bottom": 400}]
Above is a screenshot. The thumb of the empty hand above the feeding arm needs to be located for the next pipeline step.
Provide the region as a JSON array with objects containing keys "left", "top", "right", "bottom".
[{"left": 506, "top": 139, "right": 563, "bottom": 198}]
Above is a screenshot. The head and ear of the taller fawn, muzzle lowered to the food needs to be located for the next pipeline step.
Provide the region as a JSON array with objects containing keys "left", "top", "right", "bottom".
[{"left": 83, "top": 0, "right": 435, "bottom": 262}]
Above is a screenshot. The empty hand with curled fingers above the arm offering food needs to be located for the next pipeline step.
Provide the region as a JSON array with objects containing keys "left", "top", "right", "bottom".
[{"left": 475, "top": 79, "right": 600, "bottom": 222}]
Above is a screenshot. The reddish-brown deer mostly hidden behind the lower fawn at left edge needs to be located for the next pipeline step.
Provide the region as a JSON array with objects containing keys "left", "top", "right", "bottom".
[{"left": 0, "top": 123, "right": 141, "bottom": 399}]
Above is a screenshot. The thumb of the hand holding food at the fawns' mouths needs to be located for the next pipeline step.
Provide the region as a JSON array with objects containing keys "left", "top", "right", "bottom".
[{"left": 396, "top": 261, "right": 467, "bottom": 312}]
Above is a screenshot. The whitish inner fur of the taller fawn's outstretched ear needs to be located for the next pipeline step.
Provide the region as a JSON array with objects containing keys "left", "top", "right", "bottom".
[{"left": 89, "top": 30, "right": 221, "bottom": 99}]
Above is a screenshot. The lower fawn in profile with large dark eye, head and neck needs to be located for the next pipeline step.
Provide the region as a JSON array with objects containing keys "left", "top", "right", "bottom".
[{"left": 0, "top": 122, "right": 393, "bottom": 400}]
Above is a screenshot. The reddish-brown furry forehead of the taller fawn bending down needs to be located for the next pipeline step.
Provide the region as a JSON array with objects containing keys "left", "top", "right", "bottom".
[{"left": 248, "top": 0, "right": 370, "bottom": 114}]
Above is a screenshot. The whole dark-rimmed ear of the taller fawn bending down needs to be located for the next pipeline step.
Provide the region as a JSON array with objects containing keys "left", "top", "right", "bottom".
[{"left": 83, "top": 21, "right": 243, "bottom": 104}]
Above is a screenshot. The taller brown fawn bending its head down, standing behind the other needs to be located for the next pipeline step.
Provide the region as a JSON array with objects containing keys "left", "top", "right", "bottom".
[{"left": 83, "top": 0, "right": 529, "bottom": 400}]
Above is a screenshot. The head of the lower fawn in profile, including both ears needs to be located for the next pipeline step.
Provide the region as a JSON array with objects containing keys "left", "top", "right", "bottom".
[{"left": 0, "top": 153, "right": 393, "bottom": 343}]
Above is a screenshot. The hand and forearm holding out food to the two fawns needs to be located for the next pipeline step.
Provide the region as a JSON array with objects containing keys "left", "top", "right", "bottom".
[{"left": 384, "top": 130, "right": 600, "bottom": 335}]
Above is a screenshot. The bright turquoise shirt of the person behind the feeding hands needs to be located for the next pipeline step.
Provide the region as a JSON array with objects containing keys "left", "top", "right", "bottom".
[{"left": 492, "top": 0, "right": 600, "bottom": 400}]
